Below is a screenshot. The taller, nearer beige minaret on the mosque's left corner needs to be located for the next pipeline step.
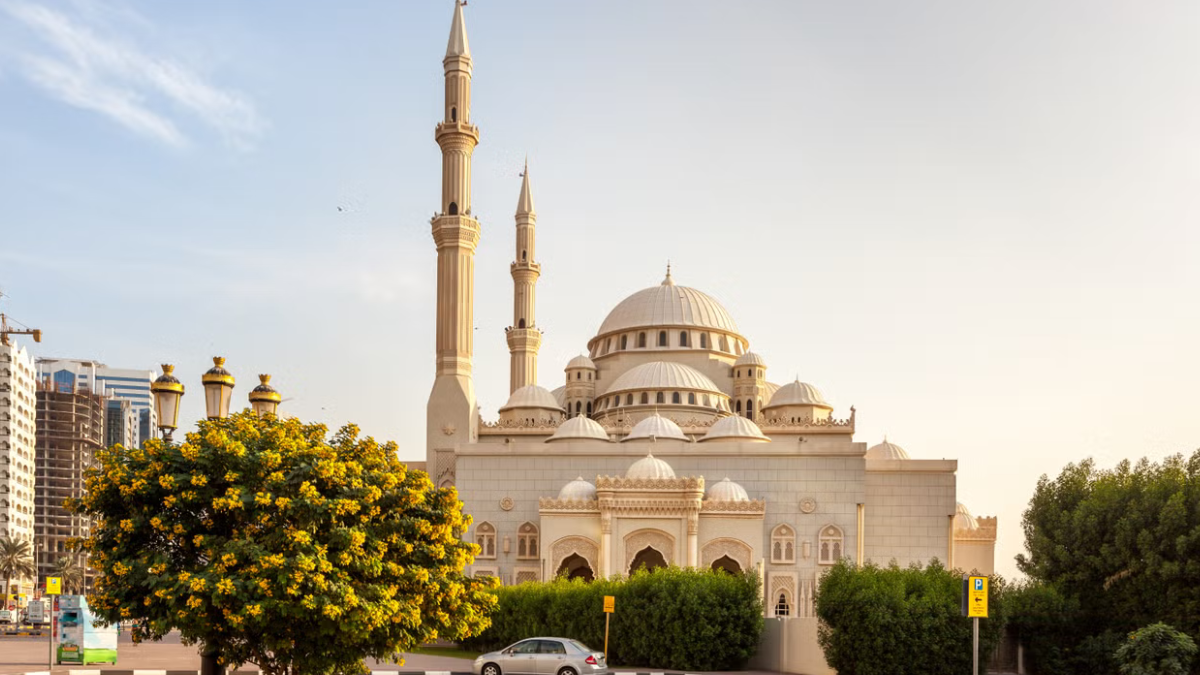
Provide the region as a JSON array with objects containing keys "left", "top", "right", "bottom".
[{"left": 425, "top": 0, "right": 480, "bottom": 478}]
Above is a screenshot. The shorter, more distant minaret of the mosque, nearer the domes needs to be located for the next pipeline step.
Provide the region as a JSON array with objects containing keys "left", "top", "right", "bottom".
[{"left": 505, "top": 159, "right": 541, "bottom": 394}]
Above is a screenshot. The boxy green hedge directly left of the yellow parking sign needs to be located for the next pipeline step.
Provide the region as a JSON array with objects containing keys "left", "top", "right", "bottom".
[{"left": 816, "top": 560, "right": 1006, "bottom": 675}]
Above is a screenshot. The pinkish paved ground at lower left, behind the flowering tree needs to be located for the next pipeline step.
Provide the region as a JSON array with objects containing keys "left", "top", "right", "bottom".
[{"left": 0, "top": 633, "right": 470, "bottom": 675}]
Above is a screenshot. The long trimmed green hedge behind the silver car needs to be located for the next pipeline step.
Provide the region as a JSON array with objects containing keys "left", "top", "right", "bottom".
[{"left": 461, "top": 567, "right": 763, "bottom": 670}]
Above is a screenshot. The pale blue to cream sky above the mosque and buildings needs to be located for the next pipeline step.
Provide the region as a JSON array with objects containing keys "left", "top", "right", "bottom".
[{"left": 0, "top": 0, "right": 1200, "bottom": 575}]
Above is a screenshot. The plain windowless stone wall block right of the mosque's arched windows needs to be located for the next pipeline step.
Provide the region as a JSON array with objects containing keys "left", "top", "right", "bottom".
[{"left": 863, "top": 460, "right": 958, "bottom": 567}]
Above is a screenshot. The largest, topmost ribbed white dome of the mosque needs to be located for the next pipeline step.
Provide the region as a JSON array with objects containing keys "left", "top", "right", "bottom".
[{"left": 596, "top": 271, "right": 738, "bottom": 335}]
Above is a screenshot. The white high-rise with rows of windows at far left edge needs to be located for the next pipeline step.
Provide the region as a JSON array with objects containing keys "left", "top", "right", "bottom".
[{"left": 0, "top": 342, "right": 37, "bottom": 545}]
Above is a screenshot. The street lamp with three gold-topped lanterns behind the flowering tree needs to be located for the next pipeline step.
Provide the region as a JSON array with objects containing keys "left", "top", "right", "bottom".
[{"left": 150, "top": 357, "right": 282, "bottom": 675}]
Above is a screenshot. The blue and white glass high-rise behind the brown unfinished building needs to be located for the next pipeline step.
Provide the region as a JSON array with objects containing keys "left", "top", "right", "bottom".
[{"left": 37, "top": 358, "right": 158, "bottom": 447}]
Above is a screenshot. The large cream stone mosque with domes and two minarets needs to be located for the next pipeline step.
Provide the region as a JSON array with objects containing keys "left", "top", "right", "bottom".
[{"left": 425, "top": 2, "right": 996, "bottom": 617}]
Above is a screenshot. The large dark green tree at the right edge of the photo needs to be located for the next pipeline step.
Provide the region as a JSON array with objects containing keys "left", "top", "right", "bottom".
[{"left": 1013, "top": 450, "right": 1200, "bottom": 675}]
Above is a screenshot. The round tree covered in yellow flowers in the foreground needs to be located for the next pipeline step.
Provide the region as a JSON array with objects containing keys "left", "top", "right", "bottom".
[{"left": 70, "top": 412, "right": 496, "bottom": 675}]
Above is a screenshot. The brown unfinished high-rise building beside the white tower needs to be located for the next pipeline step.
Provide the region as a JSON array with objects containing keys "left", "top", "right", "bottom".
[{"left": 35, "top": 374, "right": 106, "bottom": 584}]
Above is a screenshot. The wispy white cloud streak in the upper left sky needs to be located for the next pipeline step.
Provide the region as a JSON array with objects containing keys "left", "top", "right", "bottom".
[{"left": 2, "top": 1, "right": 266, "bottom": 148}]
